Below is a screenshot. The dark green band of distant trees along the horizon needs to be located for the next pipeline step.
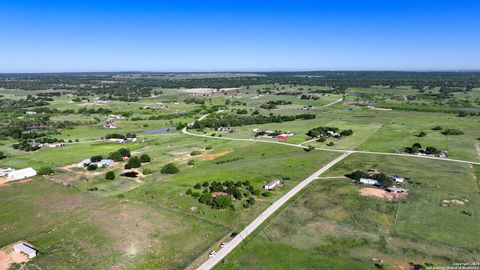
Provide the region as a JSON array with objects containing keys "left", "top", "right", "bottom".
[{"left": 0, "top": 71, "right": 480, "bottom": 91}]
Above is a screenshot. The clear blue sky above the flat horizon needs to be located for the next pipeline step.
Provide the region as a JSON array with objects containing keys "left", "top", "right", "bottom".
[{"left": 0, "top": 0, "right": 480, "bottom": 72}]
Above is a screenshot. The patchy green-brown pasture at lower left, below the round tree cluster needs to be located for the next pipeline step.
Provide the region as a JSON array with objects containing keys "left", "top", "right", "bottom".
[{"left": 0, "top": 178, "right": 226, "bottom": 269}]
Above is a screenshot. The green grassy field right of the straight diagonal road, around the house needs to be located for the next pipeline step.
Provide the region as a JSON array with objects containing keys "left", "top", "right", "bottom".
[{"left": 217, "top": 154, "right": 480, "bottom": 269}]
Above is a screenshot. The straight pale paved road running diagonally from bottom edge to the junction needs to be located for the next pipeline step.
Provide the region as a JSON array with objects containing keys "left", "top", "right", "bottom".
[{"left": 198, "top": 151, "right": 351, "bottom": 270}]
